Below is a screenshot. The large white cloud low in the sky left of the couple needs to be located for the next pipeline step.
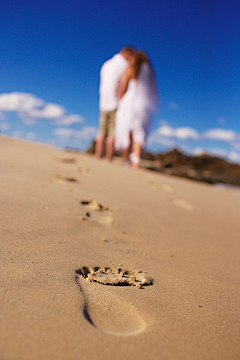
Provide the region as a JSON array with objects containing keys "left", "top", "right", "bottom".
[{"left": 0, "top": 92, "right": 83, "bottom": 126}]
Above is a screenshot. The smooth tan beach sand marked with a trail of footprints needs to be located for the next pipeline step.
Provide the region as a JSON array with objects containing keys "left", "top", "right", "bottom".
[{"left": 0, "top": 136, "right": 240, "bottom": 360}]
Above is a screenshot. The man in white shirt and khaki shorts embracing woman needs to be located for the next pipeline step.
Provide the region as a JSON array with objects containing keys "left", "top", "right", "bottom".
[{"left": 95, "top": 47, "right": 134, "bottom": 161}]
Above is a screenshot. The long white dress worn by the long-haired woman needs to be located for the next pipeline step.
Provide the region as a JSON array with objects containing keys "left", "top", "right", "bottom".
[{"left": 115, "top": 63, "right": 158, "bottom": 150}]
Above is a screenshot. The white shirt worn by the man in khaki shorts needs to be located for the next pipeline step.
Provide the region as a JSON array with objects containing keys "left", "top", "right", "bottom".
[{"left": 99, "top": 54, "right": 129, "bottom": 111}]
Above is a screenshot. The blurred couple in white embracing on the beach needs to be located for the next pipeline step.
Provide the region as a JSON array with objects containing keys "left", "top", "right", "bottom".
[{"left": 96, "top": 47, "right": 158, "bottom": 169}]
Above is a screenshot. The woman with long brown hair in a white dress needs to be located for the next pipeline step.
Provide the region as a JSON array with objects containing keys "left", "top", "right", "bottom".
[{"left": 115, "top": 51, "right": 158, "bottom": 169}]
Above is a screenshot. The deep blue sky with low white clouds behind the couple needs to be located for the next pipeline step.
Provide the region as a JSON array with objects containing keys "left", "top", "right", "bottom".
[{"left": 0, "top": 0, "right": 240, "bottom": 163}]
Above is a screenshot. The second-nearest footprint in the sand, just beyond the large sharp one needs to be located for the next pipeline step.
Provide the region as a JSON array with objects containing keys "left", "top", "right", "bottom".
[{"left": 80, "top": 200, "right": 113, "bottom": 225}]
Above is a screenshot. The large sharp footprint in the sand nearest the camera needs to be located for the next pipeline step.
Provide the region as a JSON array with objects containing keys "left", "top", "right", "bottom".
[{"left": 76, "top": 267, "right": 153, "bottom": 336}]
